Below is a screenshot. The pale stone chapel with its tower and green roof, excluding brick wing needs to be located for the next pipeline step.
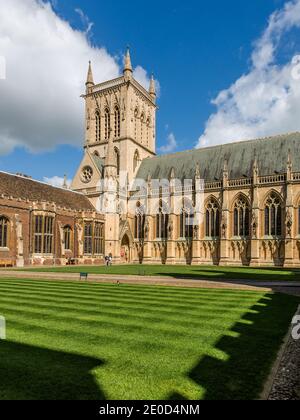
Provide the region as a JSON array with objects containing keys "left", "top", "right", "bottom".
[{"left": 72, "top": 48, "right": 300, "bottom": 267}]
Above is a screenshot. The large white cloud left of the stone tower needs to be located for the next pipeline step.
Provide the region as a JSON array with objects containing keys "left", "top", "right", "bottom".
[{"left": 0, "top": 0, "right": 120, "bottom": 154}]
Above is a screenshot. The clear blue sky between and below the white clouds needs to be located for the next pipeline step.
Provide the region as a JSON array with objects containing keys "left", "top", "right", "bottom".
[{"left": 0, "top": 0, "right": 300, "bottom": 184}]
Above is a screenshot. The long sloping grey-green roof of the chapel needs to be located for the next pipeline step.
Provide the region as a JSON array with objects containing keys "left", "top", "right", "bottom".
[{"left": 136, "top": 133, "right": 300, "bottom": 181}]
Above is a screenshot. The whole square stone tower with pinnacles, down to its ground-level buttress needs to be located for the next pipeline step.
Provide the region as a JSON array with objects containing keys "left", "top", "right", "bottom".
[{"left": 71, "top": 49, "right": 157, "bottom": 258}]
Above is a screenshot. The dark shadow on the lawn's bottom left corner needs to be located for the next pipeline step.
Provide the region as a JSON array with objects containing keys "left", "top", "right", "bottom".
[{"left": 0, "top": 341, "right": 105, "bottom": 400}]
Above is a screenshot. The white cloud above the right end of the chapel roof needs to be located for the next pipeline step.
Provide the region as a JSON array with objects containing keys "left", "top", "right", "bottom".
[{"left": 198, "top": 0, "right": 300, "bottom": 147}]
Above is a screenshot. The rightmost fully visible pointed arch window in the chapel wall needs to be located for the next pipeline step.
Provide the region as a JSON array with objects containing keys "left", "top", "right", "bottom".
[{"left": 265, "top": 193, "right": 282, "bottom": 236}]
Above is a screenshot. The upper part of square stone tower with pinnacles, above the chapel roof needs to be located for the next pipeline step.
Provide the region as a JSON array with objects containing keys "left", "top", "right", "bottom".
[{"left": 78, "top": 49, "right": 156, "bottom": 181}]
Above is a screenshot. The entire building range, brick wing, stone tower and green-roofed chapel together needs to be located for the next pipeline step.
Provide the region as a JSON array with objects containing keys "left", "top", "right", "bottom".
[{"left": 0, "top": 51, "right": 300, "bottom": 267}]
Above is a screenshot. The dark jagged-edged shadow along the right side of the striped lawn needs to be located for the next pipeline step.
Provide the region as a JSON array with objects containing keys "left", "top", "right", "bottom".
[{"left": 169, "top": 294, "right": 299, "bottom": 400}]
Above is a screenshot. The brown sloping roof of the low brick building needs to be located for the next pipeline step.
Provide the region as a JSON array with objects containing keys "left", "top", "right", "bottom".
[{"left": 0, "top": 172, "right": 95, "bottom": 210}]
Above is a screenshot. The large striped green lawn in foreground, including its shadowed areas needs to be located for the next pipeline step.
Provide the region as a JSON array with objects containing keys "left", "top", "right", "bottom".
[{"left": 0, "top": 279, "right": 299, "bottom": 400}]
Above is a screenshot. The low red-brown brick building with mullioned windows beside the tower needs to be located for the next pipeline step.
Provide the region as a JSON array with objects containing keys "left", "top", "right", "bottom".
[{"left": 0, "top": 172, "right": 104, "bottom": 267}]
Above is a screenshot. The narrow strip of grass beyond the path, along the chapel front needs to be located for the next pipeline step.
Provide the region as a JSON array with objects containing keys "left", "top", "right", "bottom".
[{"left": 15, "top": 265, "right": 300, "bottom": 281}]
